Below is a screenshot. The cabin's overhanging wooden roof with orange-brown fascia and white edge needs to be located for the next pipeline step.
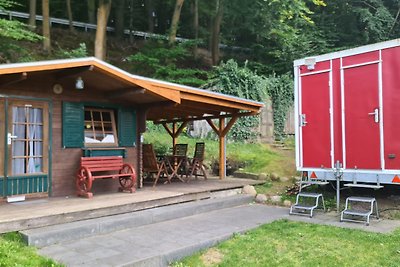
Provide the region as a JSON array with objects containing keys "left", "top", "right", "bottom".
[{"left": 0, "top": 57, "right": 264, "bottom": 121}]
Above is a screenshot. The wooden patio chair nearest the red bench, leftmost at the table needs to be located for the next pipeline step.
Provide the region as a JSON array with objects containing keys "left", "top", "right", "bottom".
[{"left": 142, "top": 144, "right": 169, "bottom": 187}]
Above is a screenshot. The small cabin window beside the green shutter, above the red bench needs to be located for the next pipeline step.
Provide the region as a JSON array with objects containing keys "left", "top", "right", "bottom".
[{"left": 84, "top": 107, "right": 118, "bottom": 146}]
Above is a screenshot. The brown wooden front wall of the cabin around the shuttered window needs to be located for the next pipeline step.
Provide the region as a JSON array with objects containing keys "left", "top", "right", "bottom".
[{"left": 0, "top": 77, "right": 141, "bottom": 196}]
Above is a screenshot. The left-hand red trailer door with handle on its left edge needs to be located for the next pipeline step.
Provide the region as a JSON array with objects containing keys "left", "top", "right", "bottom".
[{"left": 300, "top": 71, "right": 332, "bottom": 168}]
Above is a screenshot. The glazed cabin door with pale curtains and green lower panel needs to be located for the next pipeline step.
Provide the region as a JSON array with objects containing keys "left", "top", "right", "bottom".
[{"left": 0, "top": 99, "right": 49, "bottom": 196}]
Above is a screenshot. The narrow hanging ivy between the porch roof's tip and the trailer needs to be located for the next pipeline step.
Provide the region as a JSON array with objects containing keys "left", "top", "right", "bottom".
[{"left": 267, "top": 74, "right": 294, "bottom": 140}]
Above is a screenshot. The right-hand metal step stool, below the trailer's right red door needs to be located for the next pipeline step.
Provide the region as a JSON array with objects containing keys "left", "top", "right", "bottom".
[{"left": 340, "top": 197, "right": 379, "bottom": 225}]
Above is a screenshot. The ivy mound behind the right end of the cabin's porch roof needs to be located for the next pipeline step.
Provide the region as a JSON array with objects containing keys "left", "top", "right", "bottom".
[{"left": 204, "top": 60, "right": 267, "bottom": 141}]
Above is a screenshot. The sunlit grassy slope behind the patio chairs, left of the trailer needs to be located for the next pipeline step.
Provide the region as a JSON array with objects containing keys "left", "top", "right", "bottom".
[{"left": 144, "top": 130, "right": 294, "bottom": 176}]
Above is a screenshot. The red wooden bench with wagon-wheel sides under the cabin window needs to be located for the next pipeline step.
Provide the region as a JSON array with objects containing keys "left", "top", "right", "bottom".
[{"left": 76, "top": 156, "right": 136, "bottom": 198}]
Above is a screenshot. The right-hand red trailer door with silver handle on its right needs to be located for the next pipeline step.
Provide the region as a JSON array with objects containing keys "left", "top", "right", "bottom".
[{"left": 342, "top": 63, "right": 381, "bottom": 169}]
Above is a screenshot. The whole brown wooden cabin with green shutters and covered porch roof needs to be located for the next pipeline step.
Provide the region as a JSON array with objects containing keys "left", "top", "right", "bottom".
[{"left": 0, "top": 58, "right": 263, "bottom": 197}]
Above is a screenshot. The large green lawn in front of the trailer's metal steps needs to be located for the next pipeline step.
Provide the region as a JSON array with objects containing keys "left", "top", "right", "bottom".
[{"left": 176, "top": 220, "right": 400, "bottom": 267}]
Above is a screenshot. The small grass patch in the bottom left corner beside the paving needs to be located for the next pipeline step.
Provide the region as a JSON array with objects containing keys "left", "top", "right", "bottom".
[{"left": 0, "top": 233, "right": 63, "bottom": 267}]
